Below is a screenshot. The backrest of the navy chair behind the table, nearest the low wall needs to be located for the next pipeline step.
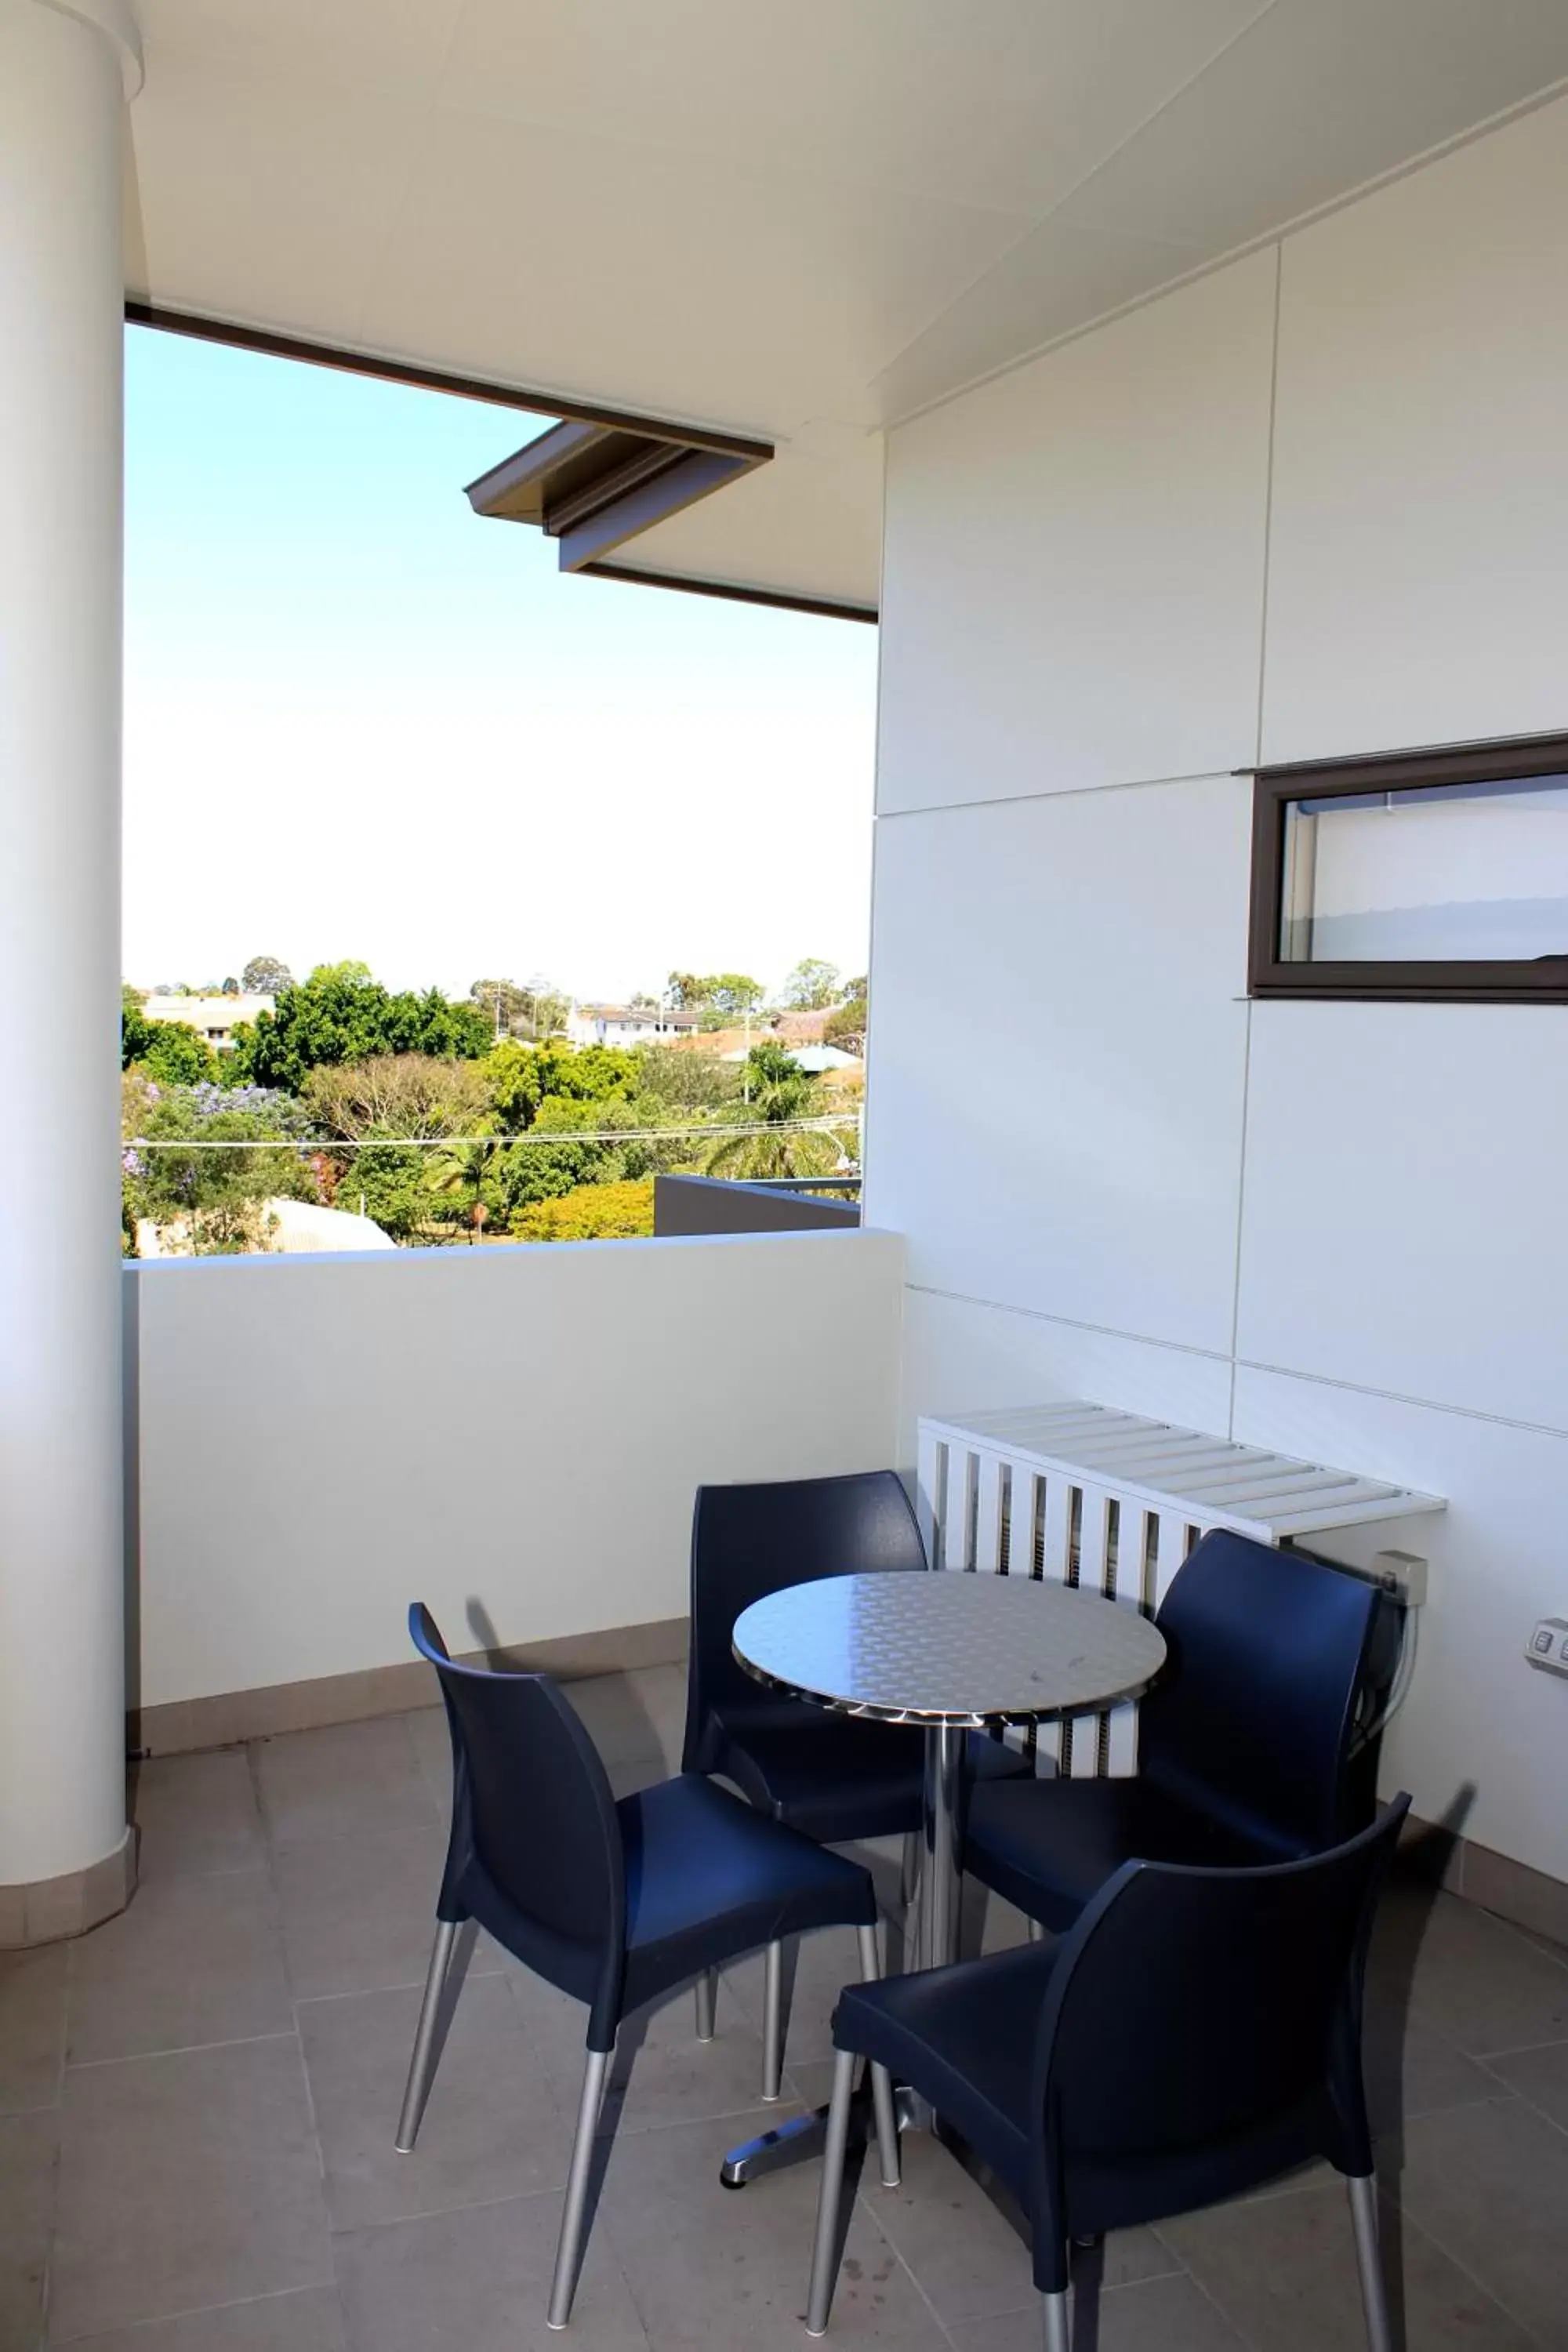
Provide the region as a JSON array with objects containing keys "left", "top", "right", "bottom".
[{"left": 684, "top": 1470, "right": 926, "bottom": 1771}]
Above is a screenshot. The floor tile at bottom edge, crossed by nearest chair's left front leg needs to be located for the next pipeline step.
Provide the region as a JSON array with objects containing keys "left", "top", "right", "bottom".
[{"left": 600, "top": 2107, "right": 945, "bottom": 2352}]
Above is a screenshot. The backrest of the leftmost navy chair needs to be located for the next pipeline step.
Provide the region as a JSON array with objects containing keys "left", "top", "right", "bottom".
[{"left": 409, "top": 1602, "right": 626, "bottom": 2049}]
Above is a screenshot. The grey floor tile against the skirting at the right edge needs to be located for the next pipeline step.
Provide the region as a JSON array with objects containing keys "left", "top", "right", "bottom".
[{"left": 1370, "top": 1889, "right": 1568, "bottom": 2058}]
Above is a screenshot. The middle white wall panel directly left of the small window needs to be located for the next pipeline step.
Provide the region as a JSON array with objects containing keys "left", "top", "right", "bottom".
[{"left": 865, "top": 776, "right": 1248, "bottom": 1350}]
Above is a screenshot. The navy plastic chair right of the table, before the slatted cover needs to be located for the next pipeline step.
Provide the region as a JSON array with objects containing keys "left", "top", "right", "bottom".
[{"left": 964, "top": 1529, "right": 1387, "bottom": 1931}]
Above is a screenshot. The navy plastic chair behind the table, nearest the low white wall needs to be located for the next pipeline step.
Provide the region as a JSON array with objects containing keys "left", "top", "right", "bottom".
[{"left": 682, "top": 1470, "right": 1029, "bottom": 2100}]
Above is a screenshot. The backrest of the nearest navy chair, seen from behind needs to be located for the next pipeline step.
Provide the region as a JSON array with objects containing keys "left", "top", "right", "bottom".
[{"left": 1032, "top": 1797, "right": 1410, "bottom": 2258}]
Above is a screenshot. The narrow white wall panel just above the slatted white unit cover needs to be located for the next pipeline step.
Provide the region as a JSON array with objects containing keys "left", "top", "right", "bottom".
[{"left": 898, "top": 1289, "right": 1229, "bottom": 1463}]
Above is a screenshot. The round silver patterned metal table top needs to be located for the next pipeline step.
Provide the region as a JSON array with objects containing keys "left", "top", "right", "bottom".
[{"left": 734, "top": 1569, "right": 1166, "bottom": 1726}]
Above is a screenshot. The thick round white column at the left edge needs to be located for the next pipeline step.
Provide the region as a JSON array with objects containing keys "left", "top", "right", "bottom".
[{"left": 0, "top": 0, "right": 139, "bottom": 1945}]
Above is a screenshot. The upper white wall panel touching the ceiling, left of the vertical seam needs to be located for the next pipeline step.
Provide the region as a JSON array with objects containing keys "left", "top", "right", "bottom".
[{"left": 879, "top": 254, "right": 1274, "bottom": 809}]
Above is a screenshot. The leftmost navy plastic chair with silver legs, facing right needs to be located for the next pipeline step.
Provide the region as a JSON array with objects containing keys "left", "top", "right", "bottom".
[{"left": 397, "top": 1602, "right": 895, "bottom": 2328}]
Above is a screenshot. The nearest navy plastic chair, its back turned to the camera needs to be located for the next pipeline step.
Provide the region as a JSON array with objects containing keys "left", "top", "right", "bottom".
[{"left": 806, "top": 1797, "right": 1410, "bottom": 2352}]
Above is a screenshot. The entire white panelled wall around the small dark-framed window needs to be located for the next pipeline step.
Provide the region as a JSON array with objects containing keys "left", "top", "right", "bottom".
[{"left": 867, "top": 101, "right": 1568, "bottom": 1877}]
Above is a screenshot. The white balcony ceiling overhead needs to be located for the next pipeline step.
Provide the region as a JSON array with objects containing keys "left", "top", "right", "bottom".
[{"left": 127, "top": 0, "right": 1568, "bottom": 604}]
